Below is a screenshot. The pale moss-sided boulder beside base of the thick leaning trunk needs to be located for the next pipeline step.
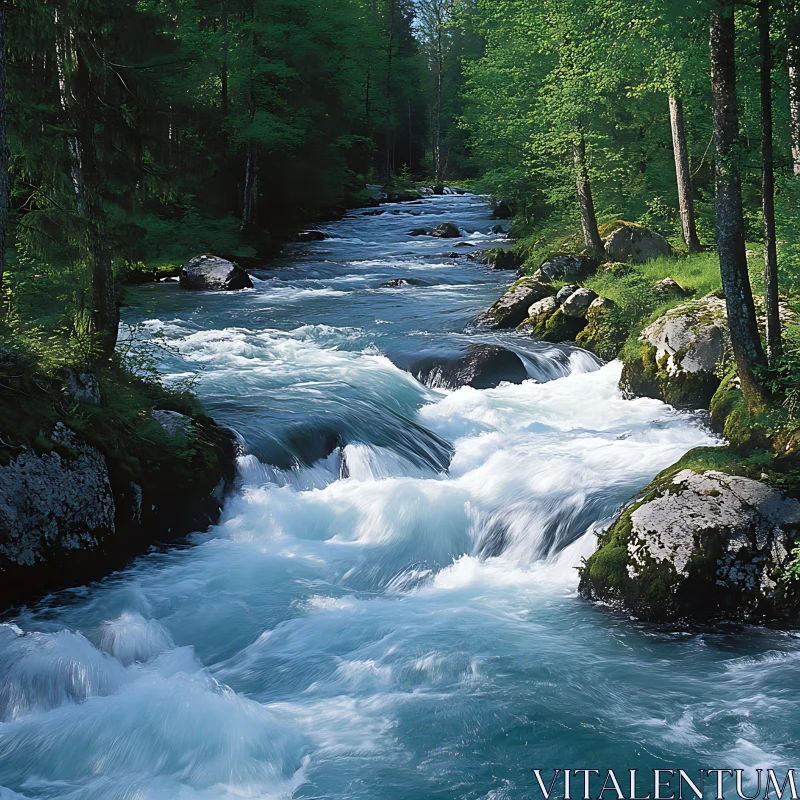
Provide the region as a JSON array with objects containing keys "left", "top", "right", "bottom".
[{"left": 620, "top": 295, "right": 731, "bottom": 408}]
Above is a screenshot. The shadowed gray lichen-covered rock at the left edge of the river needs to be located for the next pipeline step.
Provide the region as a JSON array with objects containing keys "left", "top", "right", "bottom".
[{"left": 0, "top": 423, "right": 115, "bottom": 566}]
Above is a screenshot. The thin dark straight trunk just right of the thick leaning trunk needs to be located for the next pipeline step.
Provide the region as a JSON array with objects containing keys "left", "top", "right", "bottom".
[{"left": 758, "top": 0, "right": 781, "bottom": 365}]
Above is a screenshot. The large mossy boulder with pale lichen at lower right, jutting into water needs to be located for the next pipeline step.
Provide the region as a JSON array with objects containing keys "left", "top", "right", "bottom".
[{"left": 580, "top": 469, "right": 800, "bottom": 622}]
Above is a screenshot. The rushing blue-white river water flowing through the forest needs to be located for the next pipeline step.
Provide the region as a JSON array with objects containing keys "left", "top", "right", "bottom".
[{"left": 0, "top": 195, "right": 800, "bottom": 800}]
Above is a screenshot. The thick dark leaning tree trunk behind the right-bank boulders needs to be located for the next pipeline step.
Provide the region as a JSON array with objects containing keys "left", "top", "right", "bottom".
[{"left": 711, "top": 0, "right": 765, "bottom": 412}]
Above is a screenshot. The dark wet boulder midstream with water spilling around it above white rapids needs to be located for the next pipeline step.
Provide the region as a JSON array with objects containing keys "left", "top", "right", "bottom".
[{"left": 410, "top": 344, "right": 528, "bottom": 389}]
